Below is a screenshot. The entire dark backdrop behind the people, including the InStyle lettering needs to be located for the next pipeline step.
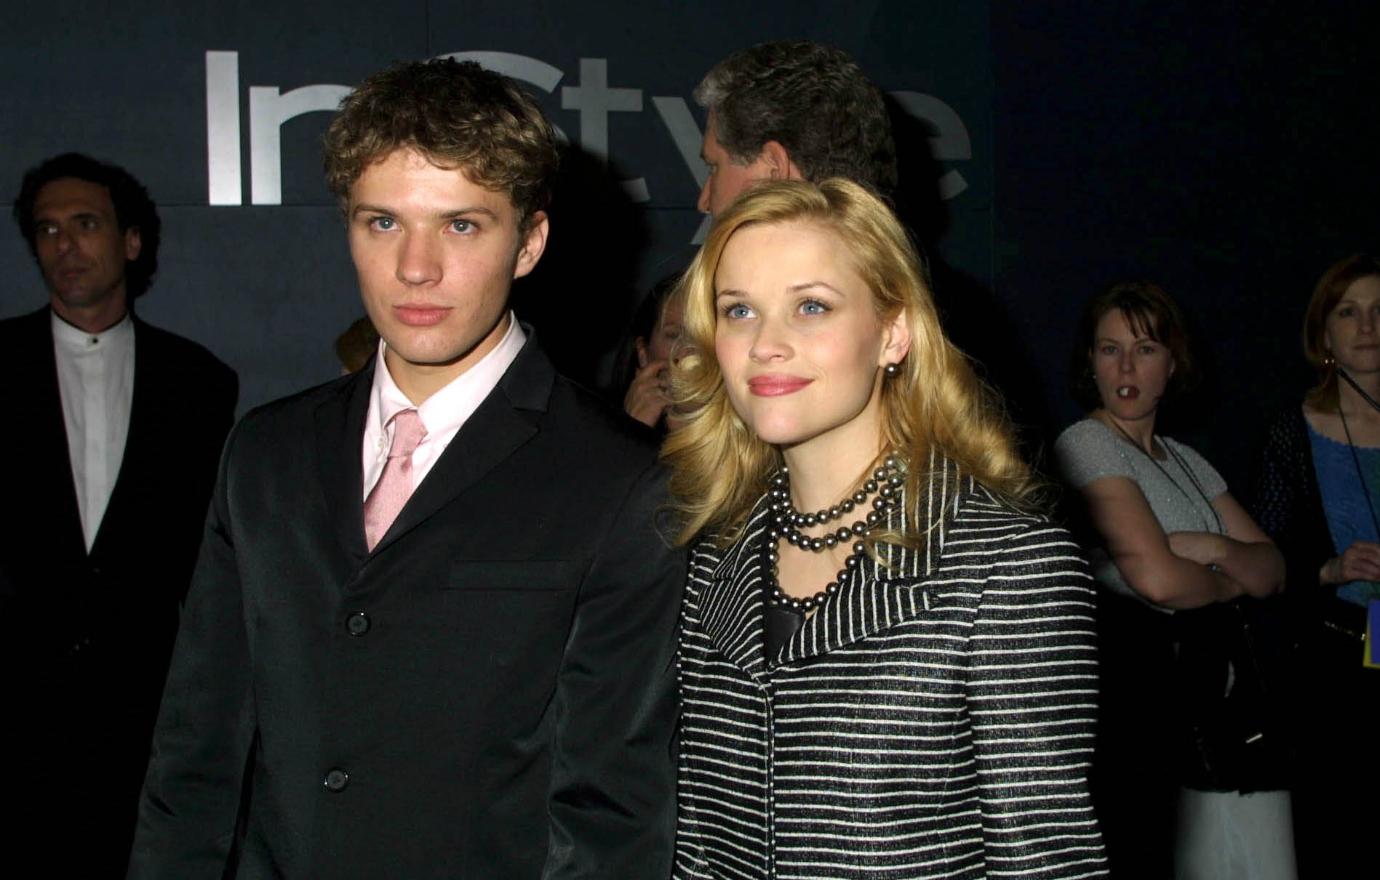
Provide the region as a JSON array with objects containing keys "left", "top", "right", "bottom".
[{"left": 0, "top": 0, "right": 1380, "bottom": 493}]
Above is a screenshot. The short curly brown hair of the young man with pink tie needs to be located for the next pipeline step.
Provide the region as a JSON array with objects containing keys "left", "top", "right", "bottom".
[{"left": 324, "top": 58, "right": 560, "bottom": 229}]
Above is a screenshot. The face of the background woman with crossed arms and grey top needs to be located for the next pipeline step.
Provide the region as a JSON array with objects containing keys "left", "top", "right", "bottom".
[{"left": 1089, "top": 309, "right": 1174, "bottom": 421}]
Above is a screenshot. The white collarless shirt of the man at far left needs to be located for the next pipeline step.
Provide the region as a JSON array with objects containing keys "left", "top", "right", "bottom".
[{"left": 52, "top": 312, "right": 134, "bottom": 550}]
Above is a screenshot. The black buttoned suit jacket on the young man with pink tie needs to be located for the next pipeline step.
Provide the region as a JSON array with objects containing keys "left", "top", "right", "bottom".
[{"left": 130, "top": 341, "right": 684, "bottom": 880}]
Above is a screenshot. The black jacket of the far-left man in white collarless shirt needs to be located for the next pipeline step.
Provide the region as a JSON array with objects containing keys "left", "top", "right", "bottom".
[{"left": 0, "top": 309, "right": 236, "bottom": 877}]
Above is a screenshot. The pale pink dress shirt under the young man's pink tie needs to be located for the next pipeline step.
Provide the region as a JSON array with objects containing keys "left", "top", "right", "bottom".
[{"left": 363, "top": 312, "right": 527, "bottom": 499}]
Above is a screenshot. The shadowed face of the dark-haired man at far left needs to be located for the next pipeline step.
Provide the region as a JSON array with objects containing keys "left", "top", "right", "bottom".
[{"left": 33, "top": 178, "right": 139, "bottom": 323}]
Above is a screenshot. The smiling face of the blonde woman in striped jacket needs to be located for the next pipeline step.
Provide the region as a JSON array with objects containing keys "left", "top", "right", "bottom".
[{"left": 715, "top": 223, "right": 904, "bottom": 454}]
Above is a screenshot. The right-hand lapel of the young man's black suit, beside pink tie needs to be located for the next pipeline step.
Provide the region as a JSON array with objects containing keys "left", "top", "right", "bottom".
[{"left": 369, "top": 337, "right": 556, "bottom": 553}]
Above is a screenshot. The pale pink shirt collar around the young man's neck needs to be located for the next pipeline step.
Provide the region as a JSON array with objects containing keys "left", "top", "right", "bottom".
[{"left": 371, "top": 312, "right": 527, "bottom": 437}]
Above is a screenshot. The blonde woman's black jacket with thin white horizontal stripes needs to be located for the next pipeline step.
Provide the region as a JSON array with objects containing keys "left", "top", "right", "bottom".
[{"left": 673, "top": 461, "right": 1107, "bottom": 880}]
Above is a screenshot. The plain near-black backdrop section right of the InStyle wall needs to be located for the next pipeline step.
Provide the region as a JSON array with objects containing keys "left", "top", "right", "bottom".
[{"left": 992, "top": 0, "right": 1380, "bottom": 494}]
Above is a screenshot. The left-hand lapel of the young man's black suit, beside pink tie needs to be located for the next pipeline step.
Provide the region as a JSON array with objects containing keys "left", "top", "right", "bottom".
[{"left": 316, "top": 366, "right": 374, "bottom": 563}]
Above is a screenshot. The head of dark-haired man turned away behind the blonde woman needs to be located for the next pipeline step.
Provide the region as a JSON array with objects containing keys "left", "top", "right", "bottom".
[{"left": 694, "top": 40, "right": 896, "bottom": 214}]
